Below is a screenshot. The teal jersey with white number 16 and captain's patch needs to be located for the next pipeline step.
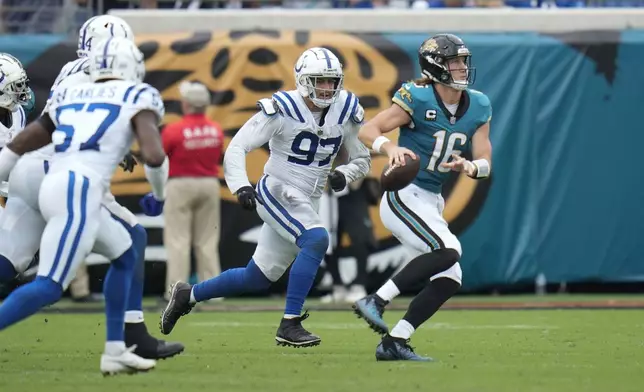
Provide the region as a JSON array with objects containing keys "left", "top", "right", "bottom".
[{"left": 392, "top": 82, "right": 492, "bottom": 193}]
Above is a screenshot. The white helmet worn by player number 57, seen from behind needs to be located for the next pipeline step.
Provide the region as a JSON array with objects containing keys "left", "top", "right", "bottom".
[{"left": 89, "top": 37, "right": 145, "bottom": 83}]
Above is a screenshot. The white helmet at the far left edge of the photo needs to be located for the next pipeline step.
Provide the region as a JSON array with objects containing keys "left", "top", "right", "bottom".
[{"left": 0, "top": 53, "right": 31, "bottom": 111}]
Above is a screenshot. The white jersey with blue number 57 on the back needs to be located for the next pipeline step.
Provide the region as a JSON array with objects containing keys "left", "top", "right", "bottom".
[{"left": 48, "top": 80, "right": 164, "bottom": 190}]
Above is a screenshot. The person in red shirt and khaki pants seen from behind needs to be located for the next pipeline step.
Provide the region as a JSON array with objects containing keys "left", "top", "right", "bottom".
[{"left": 161, "top": 82, "right": 224, "bottom": 298}]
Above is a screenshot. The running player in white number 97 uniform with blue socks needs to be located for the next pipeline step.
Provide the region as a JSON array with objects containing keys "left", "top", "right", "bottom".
[{"left": 161, "top": 48, "right": 371, "bottom": 347}]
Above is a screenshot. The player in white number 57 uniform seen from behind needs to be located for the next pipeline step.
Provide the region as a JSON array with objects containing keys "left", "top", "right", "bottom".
[{"left": 0, "top": 38, "right": 168, "bottom": 374}]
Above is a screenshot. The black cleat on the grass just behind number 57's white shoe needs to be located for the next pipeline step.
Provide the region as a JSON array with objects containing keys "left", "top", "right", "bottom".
[{"left": 125, "top": 323, "right": 185, "bottom": 359}]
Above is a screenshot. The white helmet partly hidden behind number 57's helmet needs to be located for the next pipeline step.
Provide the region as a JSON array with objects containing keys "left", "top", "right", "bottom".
[{"left": 76, "top": 15, "right": 134, "bottom": 57}]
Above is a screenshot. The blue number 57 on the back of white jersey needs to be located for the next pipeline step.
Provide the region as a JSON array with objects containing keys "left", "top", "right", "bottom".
[{"left": 55, "top": 102, "right": 121, "bottom": 152}]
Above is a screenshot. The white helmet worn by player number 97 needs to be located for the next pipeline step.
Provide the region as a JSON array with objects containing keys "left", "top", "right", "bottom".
[{"left": 295, "top": 48, "right": 344, "bottom": 108}]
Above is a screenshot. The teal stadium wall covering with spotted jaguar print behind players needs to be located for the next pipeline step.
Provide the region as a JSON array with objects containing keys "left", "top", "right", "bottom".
[{"left": 8, "top": 26, "right": 644, "bottom": 293}]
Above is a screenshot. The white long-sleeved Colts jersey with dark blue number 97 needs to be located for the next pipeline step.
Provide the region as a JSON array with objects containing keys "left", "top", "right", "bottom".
[{"left": 224, "top": 91, "right": 370, "bottom": 198}]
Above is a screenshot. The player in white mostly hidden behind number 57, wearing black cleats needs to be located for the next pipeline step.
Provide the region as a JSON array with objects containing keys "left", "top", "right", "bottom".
[{"left": 0, "top": 15, "right": 184, "bottom": 359}]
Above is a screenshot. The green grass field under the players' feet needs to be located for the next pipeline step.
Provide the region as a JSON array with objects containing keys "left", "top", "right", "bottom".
[{"left": 0, "top": 296, "right": 644, "bottom": 392}]
